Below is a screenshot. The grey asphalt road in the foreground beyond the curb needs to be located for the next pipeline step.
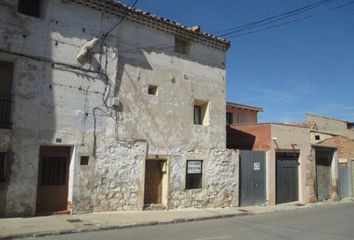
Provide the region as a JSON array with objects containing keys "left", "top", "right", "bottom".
[{"left": 22, "top": 203, "right": 354, "bottom": 240}]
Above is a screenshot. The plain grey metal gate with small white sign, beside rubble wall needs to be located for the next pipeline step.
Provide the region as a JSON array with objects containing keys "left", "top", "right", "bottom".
[{"left": 240, "top": 150, "right": 266, "bottom": 206}]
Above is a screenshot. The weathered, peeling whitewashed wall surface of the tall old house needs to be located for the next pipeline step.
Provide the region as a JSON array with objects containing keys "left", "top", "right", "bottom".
[{"left": 0, "top": 0, "right": 237, "bottom": 216}]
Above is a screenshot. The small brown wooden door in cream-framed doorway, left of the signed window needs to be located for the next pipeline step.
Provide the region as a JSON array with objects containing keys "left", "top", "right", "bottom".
[{"left": 144, "top": 160, "right": 163, "bottom": 205}]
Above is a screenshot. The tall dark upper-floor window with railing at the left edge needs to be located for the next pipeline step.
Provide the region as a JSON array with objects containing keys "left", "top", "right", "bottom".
[{"left": 0, "top": 61, "right": 13, "bottom": 128}]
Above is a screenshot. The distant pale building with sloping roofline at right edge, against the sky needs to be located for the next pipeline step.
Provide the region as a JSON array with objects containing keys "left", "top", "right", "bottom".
[{"left": 305, "top": 113, "right": 354, "bottom": 140}]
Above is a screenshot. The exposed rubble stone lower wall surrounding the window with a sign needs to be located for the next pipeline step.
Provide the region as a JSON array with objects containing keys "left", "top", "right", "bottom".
[{"left": 168, "top": 149, "right": 239, "bottom": 208}]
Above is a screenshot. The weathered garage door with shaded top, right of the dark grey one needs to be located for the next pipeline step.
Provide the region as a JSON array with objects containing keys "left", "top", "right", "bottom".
[{"left": 316, "top": 149, "right": 333, "bottom": 201}]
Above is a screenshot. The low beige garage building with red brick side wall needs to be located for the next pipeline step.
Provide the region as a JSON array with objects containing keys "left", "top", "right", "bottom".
[{"left": 227, "top": 123, "right": 338, "bottom": 205}]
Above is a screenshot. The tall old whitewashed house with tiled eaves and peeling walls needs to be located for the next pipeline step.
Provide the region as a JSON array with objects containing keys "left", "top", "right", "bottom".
[{"left": 0, "top": 0, "right": 238, "bottom": 216}]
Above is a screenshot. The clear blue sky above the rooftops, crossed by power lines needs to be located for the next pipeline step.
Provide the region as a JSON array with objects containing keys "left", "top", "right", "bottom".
[{"left": 120, "top": 0, "right": 354, "bottom": 122}]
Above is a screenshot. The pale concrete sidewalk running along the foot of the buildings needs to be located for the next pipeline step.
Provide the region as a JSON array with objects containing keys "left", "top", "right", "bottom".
[{"left": 0, "top": 199, "right": 353, "bottom": 239}]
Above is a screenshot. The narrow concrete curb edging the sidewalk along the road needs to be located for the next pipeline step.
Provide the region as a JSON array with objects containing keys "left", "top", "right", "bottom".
[{"left": 0, "top": 212, "right": 253, "bottom": 240}]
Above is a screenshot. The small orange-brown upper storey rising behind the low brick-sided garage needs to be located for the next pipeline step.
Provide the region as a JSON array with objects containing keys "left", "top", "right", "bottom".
[{"left": 226, "top": 102, "right": 263, "bottom": 125}]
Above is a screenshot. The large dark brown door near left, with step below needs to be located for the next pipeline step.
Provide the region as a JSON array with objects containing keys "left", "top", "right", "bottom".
[{"left": 36, "top": 147, "right": 71, "bottom": 215}]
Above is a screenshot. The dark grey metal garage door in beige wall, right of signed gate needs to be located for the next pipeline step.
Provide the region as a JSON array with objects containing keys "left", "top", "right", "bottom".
[{"left": 276, "top": 153, "right": 299, "bottom": 204}]
